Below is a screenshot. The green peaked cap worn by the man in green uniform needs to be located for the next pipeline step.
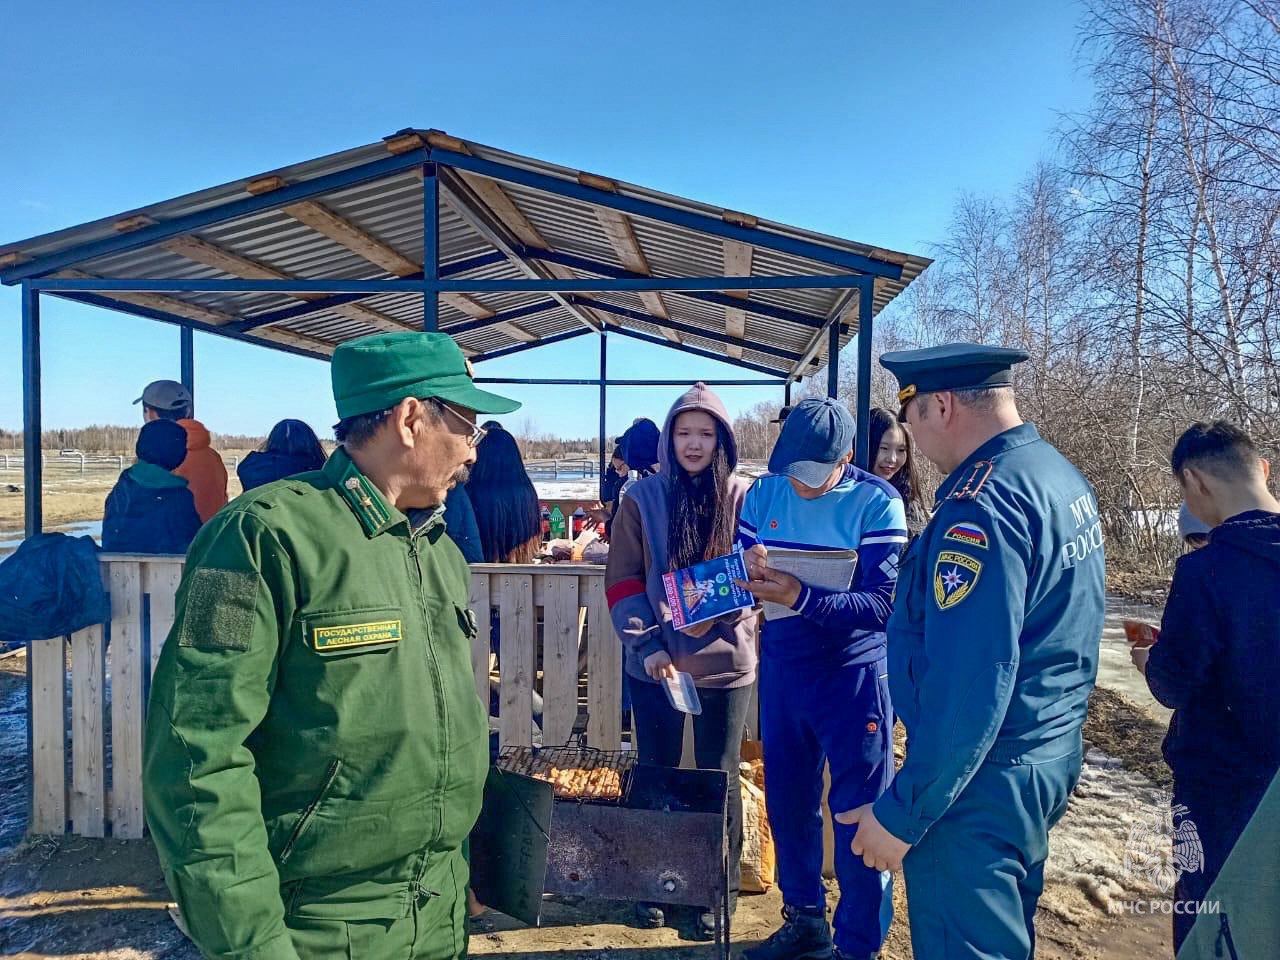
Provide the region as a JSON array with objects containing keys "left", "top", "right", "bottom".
[{"left": 329, "top": 330, "right": 520, "bottom": 420}]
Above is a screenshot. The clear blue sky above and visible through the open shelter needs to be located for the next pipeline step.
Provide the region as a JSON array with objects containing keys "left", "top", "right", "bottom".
[{"left": 0, "top": 0, "right": 1089, "bottom": 436}]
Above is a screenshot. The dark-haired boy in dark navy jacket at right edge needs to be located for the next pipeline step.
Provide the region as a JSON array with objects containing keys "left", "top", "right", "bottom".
[{"left": 1133, "top": 420, "right": 1280, "bottom": 952}]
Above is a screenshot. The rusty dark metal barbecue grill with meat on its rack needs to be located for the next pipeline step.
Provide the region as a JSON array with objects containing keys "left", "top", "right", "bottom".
[{"left": 471, "top": 745, "right": 730, "bottom": 960}]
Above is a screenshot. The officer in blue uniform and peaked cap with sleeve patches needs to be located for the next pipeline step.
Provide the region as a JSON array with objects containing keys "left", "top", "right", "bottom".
[{"left": 840, "top": 343, "right": 1103, "bottom": 960}]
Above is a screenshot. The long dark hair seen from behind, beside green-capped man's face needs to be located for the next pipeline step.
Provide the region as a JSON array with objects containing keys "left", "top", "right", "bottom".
[{"left": 467, "top": 424, "right": 543, "bottom": 563}]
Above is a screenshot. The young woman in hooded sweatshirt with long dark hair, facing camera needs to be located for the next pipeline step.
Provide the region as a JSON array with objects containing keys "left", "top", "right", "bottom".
[{"left": 604, "top": 383, "right": 755, "bottom": 938}]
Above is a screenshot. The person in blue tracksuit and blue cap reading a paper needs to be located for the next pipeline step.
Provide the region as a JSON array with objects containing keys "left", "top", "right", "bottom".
[{"left": 739, "top": 399, "right": 906, "bottom": 960}]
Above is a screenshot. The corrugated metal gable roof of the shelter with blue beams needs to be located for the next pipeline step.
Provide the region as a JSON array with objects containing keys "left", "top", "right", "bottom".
[{"left": 0, "top": 129, "right": 931, "bottom": 378}]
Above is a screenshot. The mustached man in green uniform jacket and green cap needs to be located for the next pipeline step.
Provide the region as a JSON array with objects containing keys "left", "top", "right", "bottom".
[{"left": 143, "top": 333, "right": 520, "bottom": 960}]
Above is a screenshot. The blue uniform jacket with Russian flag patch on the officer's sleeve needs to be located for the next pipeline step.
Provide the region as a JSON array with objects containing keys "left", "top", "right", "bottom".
[{"left": 876, "top": 424, "right": 1105, "bottom": 844}]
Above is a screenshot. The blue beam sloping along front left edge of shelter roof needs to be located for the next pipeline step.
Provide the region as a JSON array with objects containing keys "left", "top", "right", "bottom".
[{"left": 0, "top": 148, "right": 429, "bottom": 283}]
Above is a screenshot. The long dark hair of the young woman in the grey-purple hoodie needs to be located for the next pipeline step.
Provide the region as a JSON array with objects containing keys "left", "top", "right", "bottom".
[{"left": 667, "top": 411, "right": 737, "bottom": 570}]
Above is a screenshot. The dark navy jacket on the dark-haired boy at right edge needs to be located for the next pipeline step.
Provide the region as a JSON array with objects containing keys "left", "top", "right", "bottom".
[{"left": 1147, "top": 511, "right": 1280, "bottom": 781}]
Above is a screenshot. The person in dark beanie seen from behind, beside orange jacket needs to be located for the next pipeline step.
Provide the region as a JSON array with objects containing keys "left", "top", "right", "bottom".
[{"left": 102, "top": 420, "right": 200, "bottom": 553}]
